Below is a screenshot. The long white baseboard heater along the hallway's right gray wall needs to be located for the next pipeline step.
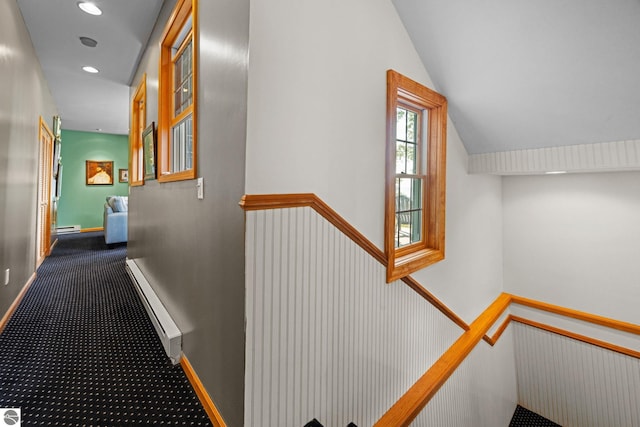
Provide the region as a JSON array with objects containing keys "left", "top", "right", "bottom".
[{"left": 126, "top": 259, "right": 182, "bottom": 365}]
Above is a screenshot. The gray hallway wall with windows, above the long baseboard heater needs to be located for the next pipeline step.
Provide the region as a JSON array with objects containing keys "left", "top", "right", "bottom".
[{"left": 128, "top": 0, "right": 249, "bottom": 426}]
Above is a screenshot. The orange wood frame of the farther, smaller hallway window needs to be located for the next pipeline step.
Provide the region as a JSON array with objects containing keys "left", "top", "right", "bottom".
[{"left": 129, "top": 73, "right": 147, "bottom": 187}]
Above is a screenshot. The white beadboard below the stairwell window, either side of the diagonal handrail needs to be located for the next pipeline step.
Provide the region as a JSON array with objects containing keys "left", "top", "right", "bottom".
[{"left": 245, "top": 207, "right": 515, "bottom": 427}]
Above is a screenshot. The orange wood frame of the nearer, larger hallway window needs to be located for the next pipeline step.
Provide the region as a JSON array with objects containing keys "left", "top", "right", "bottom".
[{"left": 157, "top": 0, "right": 198, "bottom": 182}]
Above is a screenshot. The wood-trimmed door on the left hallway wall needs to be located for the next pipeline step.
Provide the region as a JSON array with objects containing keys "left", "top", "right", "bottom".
[{"left": 36, "top": 117, "right": 53, "bottom": 268}]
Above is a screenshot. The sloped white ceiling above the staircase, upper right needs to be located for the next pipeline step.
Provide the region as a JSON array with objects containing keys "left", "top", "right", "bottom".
[{"left": 393, "top": 0, "right": 640, "bottom": 154}]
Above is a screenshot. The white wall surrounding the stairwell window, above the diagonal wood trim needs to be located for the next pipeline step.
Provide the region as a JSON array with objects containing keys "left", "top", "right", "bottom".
[{"left": 246, "top": 0, "right": 502, "bottom": 322}]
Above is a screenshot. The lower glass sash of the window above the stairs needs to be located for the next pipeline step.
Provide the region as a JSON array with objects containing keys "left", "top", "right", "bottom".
[{"left": 395, "top": 178, "right": 423, "bottom": 248}]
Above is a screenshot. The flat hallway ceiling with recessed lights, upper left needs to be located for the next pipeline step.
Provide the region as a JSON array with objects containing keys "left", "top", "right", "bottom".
[{"left": 17, "top": 0, "right": 163, "bottom": 134}]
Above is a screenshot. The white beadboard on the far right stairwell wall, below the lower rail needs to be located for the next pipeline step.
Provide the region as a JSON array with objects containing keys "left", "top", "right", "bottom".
[{"left": 510, "top": 322, "right": 640, "bottom": 427}]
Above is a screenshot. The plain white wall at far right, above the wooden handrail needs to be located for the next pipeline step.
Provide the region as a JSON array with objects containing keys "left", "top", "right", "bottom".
[{"left": 503, "top": 172, "right": 640, "bottom": 324}]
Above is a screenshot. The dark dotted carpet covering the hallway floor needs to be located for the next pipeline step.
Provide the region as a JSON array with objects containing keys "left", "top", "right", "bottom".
[{"left": 0, "top": 233, "right": 211, "bottom": 426}]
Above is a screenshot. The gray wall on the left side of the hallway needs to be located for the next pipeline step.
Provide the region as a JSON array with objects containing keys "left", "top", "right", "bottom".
[{"left": 0, "top": 0, "right": 57, "bottom": 317}]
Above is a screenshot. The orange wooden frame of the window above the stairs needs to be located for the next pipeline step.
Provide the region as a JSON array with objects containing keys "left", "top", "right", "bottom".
[{"left": 385, "top": 70, "right": 447, "bottom": 283}]
